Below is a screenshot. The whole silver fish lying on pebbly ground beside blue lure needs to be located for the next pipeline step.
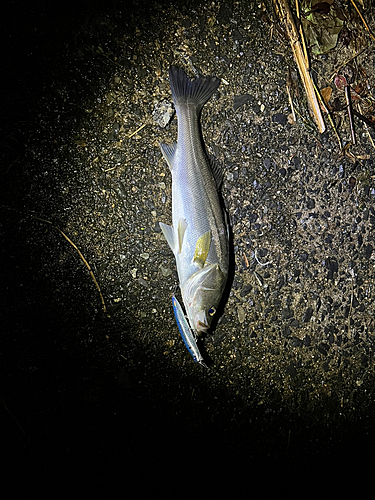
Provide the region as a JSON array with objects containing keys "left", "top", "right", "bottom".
[{"left": 159, "top": 66, "right": 229, "bottom": 334}]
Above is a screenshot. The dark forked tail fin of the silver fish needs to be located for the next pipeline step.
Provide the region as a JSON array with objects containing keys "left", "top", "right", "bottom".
[{"left": 169, "top": 66, "right": 220, "bottom": 111}]
